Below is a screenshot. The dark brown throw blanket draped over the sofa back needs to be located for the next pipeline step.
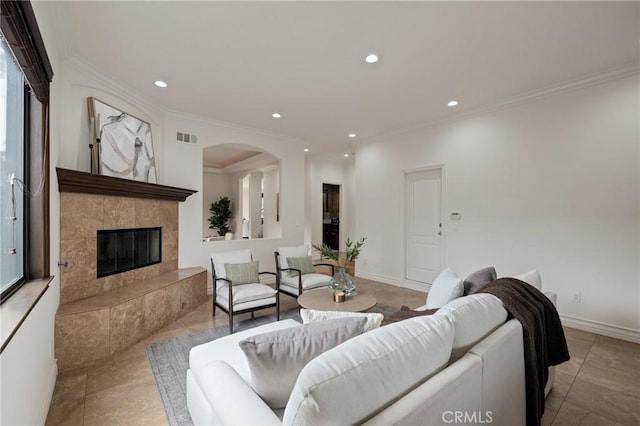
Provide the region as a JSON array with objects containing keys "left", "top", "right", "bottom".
[{"left": 477, "top": 278, "right": 570, "bottom": 426}]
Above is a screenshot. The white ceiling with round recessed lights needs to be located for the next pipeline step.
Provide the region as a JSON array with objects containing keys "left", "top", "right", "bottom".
[{"left": 38, "top": 1, "right": 640, "bottom": 152}]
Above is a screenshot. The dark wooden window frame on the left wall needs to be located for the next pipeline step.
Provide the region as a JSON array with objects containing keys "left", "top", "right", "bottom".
[{"left": 0, "top": 0, "right": 53, "bottom": 303}]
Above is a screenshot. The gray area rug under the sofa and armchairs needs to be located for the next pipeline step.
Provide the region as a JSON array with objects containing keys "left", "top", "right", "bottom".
[{"left": 145, "top": 303, "right": 398, "bottom": 426}]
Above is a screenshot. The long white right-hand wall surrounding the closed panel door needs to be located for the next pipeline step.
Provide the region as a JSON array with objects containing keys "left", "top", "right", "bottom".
[{"left": 355, "top": 75, "right": 640, "bottom": 337}]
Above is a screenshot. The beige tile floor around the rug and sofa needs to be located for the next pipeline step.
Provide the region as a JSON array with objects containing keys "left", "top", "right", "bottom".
[{"left": 46, "top": 279, "right": 640, "bottom": 426}]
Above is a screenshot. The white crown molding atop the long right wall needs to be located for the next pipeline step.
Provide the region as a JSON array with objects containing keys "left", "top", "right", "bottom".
[{"left": 356, "top": 63, "right": 640, "bottom": 147}]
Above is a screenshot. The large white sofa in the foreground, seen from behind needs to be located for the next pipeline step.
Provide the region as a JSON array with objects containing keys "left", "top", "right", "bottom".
[{"left": 187, "top": 294, "right": 553, "bottom": 426}]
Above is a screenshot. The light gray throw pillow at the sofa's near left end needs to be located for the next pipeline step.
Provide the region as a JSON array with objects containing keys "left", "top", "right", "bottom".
[{"left": 240, "top": 317, "right": 366, "bottom": 408}]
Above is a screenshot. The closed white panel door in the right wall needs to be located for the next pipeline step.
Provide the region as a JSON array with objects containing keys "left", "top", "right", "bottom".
[{"left": 405, "top": 169, "right": 443, "bottom": 284}]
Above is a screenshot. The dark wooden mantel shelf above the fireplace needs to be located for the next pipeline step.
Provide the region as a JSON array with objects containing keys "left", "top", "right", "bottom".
[{"left": 56, "top": 167, "right": 198, "bottom": 201}]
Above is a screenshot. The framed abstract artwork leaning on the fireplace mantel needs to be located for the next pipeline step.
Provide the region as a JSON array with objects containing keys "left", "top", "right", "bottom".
[{"left": 88, "top": 98, "right": 156, "bottom": 183}]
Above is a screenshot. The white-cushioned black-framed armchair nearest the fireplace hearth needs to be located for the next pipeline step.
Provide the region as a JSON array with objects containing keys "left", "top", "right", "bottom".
[{"left": 211, "top": 249, "right": 280, "bottom": 333}]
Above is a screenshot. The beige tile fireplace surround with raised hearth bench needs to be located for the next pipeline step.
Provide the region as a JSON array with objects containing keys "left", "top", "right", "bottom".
[{"left": 55, "top": 169, "right": 207, "bottom": 370}]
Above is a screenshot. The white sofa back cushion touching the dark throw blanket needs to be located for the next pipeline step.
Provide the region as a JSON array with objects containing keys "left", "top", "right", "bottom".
[{"left": 434, "top": 293, "right": 508, "bottom": 362}]
